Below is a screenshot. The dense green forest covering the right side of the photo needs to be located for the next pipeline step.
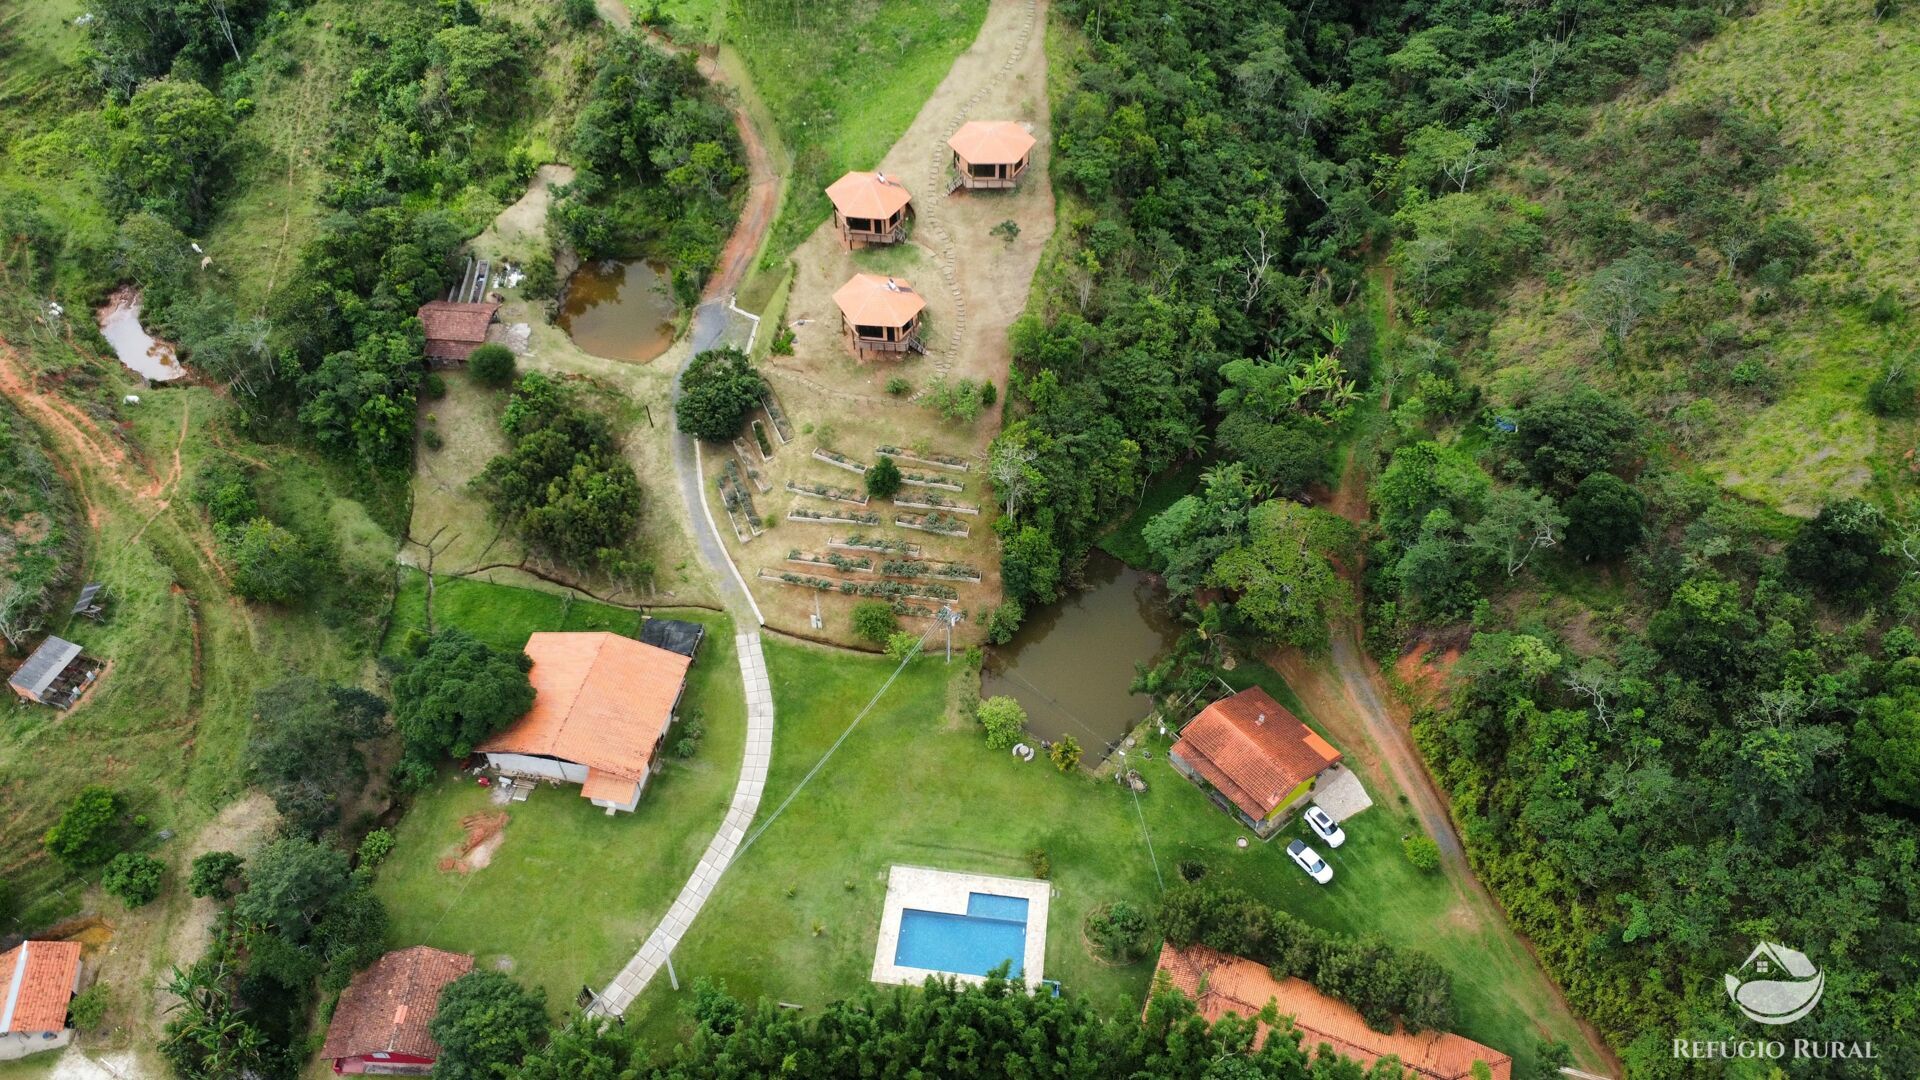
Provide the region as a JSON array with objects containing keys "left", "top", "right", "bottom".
[{"left": 993, "top": 2, "right": 1920, "bottom": 1076}]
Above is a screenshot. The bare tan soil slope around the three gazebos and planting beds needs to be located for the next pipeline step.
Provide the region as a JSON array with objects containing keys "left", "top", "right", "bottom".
[{"left": 721, "top": 2, "right": 1054, "bottom": 644}]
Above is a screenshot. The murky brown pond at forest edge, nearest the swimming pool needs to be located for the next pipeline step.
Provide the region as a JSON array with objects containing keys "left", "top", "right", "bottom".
[{"left": 981, "top": 552, "right": 1181, "bottom": 763}]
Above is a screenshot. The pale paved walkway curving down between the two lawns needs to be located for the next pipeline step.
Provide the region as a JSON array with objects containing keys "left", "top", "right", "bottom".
[{"left": 588, "top": 634, "right": 774, "bottom": 1017}]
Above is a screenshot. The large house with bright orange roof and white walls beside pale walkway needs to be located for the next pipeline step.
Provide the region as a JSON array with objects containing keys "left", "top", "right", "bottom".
[{"left": 474, "top": 632, "right": 693, "bottom": 815}]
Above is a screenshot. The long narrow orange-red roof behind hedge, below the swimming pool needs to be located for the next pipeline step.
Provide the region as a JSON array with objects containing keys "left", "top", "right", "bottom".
[{"left": 1158, "top": 944, "right": 1513, "bottom": 1080}]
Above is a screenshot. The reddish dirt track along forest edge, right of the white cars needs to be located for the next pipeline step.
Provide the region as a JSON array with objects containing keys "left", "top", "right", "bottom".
[{"left": 1265, "top": 441, "right": 1624, "bottom": 1076}]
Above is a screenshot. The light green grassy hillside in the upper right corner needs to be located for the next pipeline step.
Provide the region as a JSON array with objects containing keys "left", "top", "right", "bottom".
[{"left": 1451, "top": 0, "right": 1920, "bottom": 517}]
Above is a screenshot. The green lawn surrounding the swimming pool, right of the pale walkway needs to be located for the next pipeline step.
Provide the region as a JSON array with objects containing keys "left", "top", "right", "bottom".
[{"left": 630, "top": 642, "right": 1572, "bottom": 1067}]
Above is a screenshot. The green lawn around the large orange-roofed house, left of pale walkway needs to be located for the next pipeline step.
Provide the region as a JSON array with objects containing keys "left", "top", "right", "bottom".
[{"left": 376, "top": 573, "right": 747, "bottom": 1015}]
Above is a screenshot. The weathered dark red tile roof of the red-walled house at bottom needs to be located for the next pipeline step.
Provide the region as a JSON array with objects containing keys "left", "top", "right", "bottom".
[{"left": 321, "top": 945, "right": 474, "bottom": 1059}]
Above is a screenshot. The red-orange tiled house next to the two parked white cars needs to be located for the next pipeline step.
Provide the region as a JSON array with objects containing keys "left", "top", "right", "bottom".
[{"left": 1167, "top": 686, "right": 1340, "bottom": 838}]
